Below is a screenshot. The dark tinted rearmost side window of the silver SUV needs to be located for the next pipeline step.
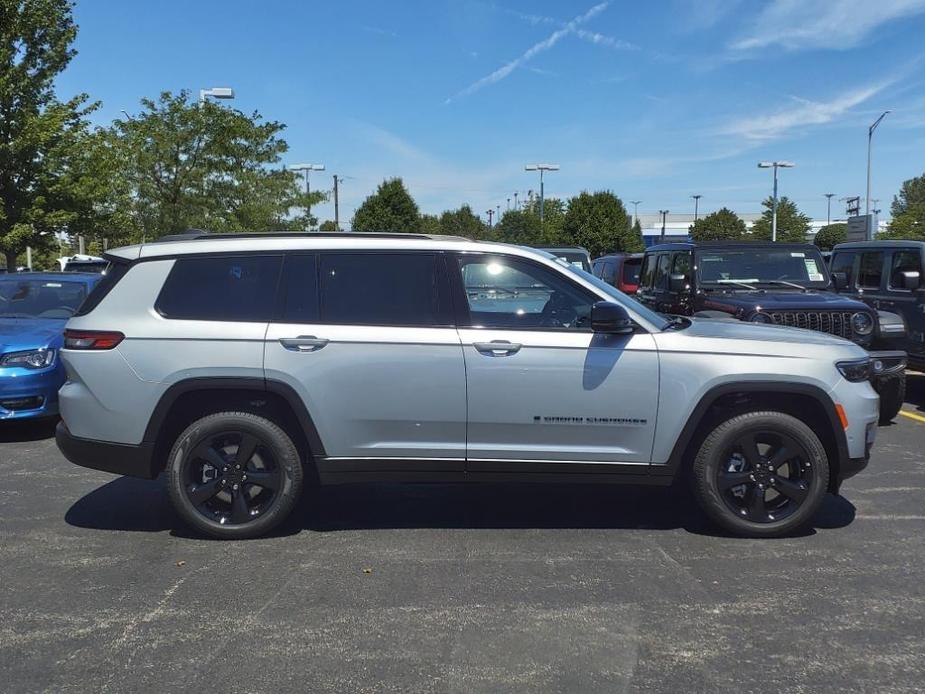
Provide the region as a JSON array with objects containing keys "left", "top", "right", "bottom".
[{"left": 155, "top": 256, "right": 282, "bottom": 321}]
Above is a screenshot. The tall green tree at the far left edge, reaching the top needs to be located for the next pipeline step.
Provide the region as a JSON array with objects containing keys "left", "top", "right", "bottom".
[{"left": 0, "top": 0, "right": 96, "bottom": 270}]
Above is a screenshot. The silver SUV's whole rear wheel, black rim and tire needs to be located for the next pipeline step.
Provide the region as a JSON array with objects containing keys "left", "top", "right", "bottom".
[{"left": 167, "top": 412, "right": 303, "bottom": 540}]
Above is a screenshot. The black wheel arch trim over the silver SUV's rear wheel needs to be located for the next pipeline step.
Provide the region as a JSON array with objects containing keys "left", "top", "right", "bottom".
[{"left": 142, "top": 376, "right": 326, "bottom": 457}]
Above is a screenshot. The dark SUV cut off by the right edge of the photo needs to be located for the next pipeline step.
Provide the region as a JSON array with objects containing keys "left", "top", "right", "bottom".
[{"left": 829, "top": 241, "right": 925, "bottom": 378}]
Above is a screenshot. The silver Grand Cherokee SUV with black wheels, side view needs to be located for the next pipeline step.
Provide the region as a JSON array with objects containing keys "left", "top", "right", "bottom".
[{"left": 57, "top": 233, "right": 878, "bottom": 538}]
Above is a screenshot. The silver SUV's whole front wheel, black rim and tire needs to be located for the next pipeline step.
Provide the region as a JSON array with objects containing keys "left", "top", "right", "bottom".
[{"left": 692, "top": 412, "right": 829, "bottom": 537}]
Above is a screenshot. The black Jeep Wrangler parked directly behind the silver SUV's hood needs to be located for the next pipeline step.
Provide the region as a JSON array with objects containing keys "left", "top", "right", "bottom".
[{"left": 636, "top": 241, "right": 906, "bottom": 423}]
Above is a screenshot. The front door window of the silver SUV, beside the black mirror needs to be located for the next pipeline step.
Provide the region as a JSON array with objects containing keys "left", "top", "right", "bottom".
[{"left": 459, "top": 256, "right": 596, "bottom": 330}]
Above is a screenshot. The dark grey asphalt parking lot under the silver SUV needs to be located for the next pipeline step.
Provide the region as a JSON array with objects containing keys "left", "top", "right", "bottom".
[{"left": 0, "top": 376, "right": 925, "bottom": 692}]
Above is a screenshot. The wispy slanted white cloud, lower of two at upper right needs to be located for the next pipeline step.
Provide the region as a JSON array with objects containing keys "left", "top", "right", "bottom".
[{"left": 722, "top": 80, "right": 893, "bottom": 140}]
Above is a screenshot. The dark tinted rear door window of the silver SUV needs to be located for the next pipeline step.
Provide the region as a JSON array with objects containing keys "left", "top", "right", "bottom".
[{"left": 320, "top": 253, "right": 448, "bottom": 326}]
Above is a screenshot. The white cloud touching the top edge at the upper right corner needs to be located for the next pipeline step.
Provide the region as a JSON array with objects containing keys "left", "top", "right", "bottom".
[{"left": 732, "top": 0, "right": 925, "bottom": 51}]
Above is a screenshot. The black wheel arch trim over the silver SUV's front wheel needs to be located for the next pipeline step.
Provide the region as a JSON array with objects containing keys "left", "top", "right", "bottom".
[{"left": 652, "top": 381, "right": 849, "bottom": 477}]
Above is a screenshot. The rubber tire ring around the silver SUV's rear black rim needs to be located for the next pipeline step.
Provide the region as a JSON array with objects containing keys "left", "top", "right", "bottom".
[{"left": 167, "top": 412, "right": 303, "bottom": 539}]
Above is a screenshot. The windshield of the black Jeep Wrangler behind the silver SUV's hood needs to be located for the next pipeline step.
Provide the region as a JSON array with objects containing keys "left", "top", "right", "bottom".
[{"left": 697, "top": 246, "right": 828, "bottom": 287}]
